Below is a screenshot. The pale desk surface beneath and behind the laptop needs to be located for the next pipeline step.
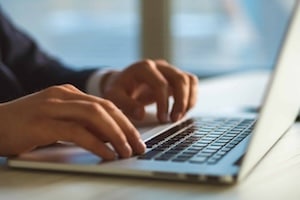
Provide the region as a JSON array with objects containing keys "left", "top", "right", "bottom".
[{"left": 0, "top": 70, "right": 300, "bottom": 200}]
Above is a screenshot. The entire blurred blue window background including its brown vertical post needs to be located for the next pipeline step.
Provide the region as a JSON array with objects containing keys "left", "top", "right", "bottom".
[{"left": 0, "top": 0, "right": 294, "bottom": 77}]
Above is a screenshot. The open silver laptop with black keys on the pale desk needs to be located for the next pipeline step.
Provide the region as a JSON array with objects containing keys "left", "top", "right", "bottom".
[{"left": 8, "top": 1, "right": 300, "bottom": 184}]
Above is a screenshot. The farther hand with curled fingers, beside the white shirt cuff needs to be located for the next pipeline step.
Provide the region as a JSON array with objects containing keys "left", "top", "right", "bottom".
[{"left": 102, "top": 60, "right": 198, "bottom": 122}]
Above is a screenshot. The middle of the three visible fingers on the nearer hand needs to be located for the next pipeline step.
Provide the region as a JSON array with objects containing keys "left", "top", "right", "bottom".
[{"left": 42, "top": 100, "right": 132, "bottom": 158}]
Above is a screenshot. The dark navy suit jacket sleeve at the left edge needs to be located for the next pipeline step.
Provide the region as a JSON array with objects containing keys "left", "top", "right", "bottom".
[{"left": 0, "top": 9, "right": 96, "bottom": 102}]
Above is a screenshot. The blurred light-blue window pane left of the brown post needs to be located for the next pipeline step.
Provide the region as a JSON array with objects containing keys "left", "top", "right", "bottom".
[{"left": 0, "top": 0, "right": 140, "bottom": 68}]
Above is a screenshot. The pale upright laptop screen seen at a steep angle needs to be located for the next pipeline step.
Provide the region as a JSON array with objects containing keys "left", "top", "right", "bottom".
[{"left": 239, "top": 1, "right": 300, "bottom": 179}]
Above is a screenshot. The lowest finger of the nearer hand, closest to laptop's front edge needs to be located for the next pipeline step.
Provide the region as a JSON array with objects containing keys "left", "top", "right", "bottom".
[{"left": 44, "top": 120, "right": 116, "bottom": 160}]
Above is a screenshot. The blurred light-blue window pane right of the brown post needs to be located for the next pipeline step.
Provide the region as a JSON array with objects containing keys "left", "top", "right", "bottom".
[{"left": 171, "top": 0, "right": 293, "bottom": 76}]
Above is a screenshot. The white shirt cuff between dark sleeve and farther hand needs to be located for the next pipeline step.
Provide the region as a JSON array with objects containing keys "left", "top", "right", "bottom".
[{"left": 86, "top": 69, "right": 113, "bottom": 97}]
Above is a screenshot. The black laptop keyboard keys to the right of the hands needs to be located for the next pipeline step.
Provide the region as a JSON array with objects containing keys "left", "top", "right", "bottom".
[{"left": 138, "top": 118, "right": 255, "bottom": 164}]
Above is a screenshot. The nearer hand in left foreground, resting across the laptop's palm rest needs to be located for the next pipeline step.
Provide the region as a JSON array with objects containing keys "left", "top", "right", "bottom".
[{"left": 0, "top": 85, "right": 145, "bottom": 160}]
